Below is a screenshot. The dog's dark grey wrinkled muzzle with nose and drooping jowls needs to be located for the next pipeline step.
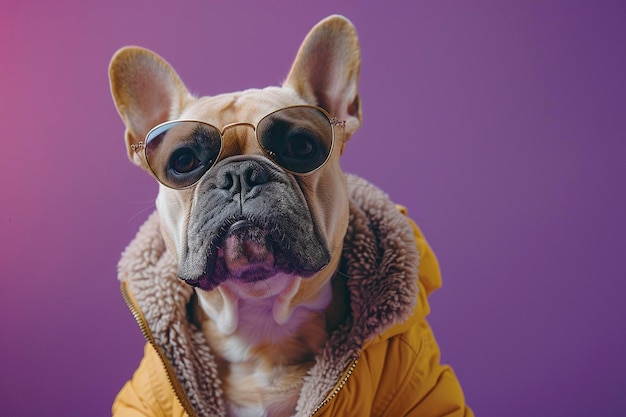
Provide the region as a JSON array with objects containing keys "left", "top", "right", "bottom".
[{"left": 179, "top": 157, "right": 330, "bottom": 290}]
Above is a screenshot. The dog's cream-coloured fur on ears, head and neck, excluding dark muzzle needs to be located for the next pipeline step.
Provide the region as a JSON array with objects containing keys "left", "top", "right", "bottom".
[{"left": 110, "top": 16, "right": 361, "bottom": 416}]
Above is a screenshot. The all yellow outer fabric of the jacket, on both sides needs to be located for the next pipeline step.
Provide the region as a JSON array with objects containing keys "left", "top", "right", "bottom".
[{"left": 113, "top": 211, "right": 474, "bottom": 417}]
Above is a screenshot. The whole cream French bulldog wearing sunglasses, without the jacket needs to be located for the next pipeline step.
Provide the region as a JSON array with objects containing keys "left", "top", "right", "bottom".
[{"left": 109, "top": 16, "right": 361, "bottom": 416}]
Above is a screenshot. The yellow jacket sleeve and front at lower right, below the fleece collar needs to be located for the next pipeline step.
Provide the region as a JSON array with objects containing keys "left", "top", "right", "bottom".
[{"left": 348, "top": 319, "right": 474, "bottom": 417}]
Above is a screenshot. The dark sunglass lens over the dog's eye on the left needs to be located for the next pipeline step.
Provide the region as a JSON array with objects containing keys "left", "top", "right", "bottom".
[{"left": 146, "top": 121, "right": 222, "bottom": 188}]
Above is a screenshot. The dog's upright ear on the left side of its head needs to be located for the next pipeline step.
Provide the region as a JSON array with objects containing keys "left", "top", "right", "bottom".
[{"left": 109, "top": 46, "right": 191, "bottom": 165}]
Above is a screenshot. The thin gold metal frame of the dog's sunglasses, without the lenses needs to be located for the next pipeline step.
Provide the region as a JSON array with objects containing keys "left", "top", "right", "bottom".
[{"left": 130, "top": 104, "right": 346, "bottom": 190}]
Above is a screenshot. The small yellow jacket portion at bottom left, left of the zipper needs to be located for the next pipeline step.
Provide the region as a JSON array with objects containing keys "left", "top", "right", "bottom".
[{"left": 112, "top": 344, "right": 185, "bottom": 417}]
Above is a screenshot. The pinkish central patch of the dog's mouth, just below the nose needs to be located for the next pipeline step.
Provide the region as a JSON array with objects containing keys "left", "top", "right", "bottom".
[{"left": 219, "top": 220, "right": 275, "bottom": 282}]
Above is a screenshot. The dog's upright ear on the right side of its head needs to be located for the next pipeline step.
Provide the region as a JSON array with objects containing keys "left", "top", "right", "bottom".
[{"left": 283, "top": 15, "right": 361, "bottom": 140}]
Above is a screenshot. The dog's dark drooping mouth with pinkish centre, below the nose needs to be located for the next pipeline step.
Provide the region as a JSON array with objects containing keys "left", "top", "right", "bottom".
[{"left": 186, "top": 219, "right": 314, "bottom": 291}]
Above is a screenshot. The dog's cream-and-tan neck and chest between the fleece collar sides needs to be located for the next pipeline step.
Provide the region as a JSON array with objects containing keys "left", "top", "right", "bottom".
[{"left": 195, "top": 277, "right": 347, "bottom": 416}]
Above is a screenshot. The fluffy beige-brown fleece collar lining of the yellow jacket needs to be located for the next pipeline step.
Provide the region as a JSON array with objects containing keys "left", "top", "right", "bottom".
[{"left": 118, "top": 175, "right": 419, "bottom": 417}]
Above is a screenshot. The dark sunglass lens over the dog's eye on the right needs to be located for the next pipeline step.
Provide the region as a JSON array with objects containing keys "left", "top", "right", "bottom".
[{"left": 257, "top": 106, "right": 333, "bottom": 174}]
